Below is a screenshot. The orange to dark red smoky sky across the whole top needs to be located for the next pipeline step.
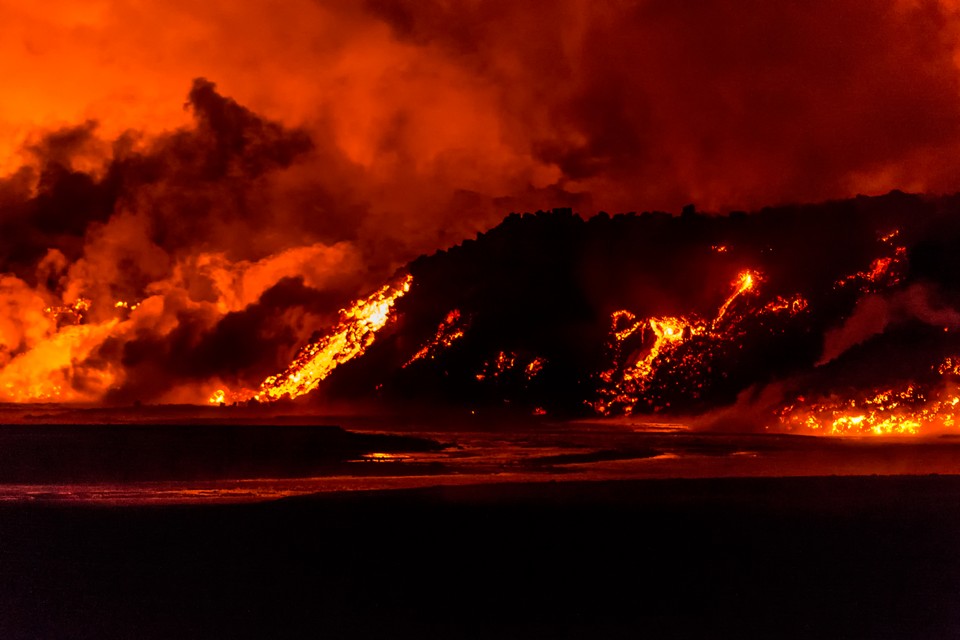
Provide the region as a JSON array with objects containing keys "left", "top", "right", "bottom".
[{"left": 0, "top": 0, "right": 960, "bottom": 225}]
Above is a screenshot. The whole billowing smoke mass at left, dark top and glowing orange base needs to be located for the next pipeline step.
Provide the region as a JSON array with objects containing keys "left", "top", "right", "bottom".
[{"left": 0, "top": 79, "right": 376, "bottom": 401}]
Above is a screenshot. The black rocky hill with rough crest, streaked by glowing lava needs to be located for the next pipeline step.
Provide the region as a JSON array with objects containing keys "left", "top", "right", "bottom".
[{"left": 326, "top": 191, "right": 960, "bottom": 416}]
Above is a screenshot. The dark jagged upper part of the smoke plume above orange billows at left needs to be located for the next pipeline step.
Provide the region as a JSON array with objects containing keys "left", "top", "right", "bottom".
[{"left": 0, "top": 79, "right": 312, "bottom": 271}]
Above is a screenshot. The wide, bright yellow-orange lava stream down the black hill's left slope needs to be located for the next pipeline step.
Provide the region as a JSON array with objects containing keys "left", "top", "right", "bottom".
[{"left": 209, "top": 275, "right": 413, "bottom": 404}]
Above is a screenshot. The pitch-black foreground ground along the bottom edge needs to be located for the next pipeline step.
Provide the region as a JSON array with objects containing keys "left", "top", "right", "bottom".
[{"left": 0, "top": 476, "right": 960, "bottom": 639}]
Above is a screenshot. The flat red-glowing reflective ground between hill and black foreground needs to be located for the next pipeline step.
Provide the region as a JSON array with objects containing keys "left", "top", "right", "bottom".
[{"left": 0, "top": 422, "right": 960, "bottom": 504}]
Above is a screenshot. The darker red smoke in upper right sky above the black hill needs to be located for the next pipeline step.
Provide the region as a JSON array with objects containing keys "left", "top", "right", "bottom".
[{"left": 368, "top": 0, "right": 960, "bottom": 210}]
